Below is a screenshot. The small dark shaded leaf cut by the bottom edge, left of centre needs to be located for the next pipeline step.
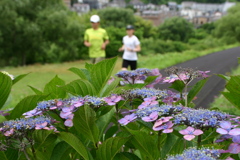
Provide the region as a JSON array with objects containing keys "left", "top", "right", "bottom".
[{"left": 51, "top": 141, "right": 70, "bottom": 160}]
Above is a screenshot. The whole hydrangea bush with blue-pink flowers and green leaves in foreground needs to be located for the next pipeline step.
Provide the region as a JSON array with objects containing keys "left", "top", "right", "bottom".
[{"left": 0, "top": 58, "right": 240, "bottom": 160}]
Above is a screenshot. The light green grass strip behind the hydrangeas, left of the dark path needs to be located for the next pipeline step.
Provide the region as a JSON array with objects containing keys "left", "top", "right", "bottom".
[{"left": 0, "top": 45, "right": 237, "bottom": 108}]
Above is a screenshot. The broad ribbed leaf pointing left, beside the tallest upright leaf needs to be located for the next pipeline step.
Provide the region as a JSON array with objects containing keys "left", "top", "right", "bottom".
[{"left": 60, "top": 79, "right": 96, "bottom": 96}]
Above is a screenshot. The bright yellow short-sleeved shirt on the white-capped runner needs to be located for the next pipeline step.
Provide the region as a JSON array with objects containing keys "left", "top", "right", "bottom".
[{"left": 84, "top": 28, "right": 109, "bottom": 58}]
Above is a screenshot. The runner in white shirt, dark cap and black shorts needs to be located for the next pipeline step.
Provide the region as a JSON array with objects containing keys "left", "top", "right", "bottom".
[{"left": 119, "top": 25, "right": 141, "bottom": 70}]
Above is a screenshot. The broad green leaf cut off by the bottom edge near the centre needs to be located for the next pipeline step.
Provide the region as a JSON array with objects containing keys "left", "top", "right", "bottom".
[{"left": 97, "top": 137, "right": 129, "bottom": 160}]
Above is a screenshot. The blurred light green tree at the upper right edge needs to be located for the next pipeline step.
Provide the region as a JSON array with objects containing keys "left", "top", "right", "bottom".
[{"left": 214, "top": 4, "right": 240, "bottom": 44}]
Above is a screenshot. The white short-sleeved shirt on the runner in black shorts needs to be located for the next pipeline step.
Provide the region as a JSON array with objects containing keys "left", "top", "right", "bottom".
[{"left": 123, "top": 35, "right": 140, "bottom": 61}]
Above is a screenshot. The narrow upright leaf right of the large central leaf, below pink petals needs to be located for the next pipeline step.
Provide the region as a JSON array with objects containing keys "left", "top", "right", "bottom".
[{"left": 96, "top": 106, "right": 116, "bottom": 138}]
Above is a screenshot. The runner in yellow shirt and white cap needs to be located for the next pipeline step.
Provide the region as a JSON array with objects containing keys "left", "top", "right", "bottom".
[{"left": 84, "top": 15, "right": 109, "bottom": 64}]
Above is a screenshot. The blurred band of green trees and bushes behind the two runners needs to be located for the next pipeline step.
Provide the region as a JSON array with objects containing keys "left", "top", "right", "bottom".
[{"left": 0, "top": 0, "right": 240, "bottom": 67}]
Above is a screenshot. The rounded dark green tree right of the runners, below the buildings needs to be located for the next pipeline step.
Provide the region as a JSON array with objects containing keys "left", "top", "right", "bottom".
[{"left": 158, "top": 17, "right": 194, "bottom": 42}]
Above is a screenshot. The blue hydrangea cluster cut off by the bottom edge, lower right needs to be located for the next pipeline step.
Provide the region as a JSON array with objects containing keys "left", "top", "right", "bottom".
[{"left": 167, "top": 148, "right": 221, "bottom": 160}]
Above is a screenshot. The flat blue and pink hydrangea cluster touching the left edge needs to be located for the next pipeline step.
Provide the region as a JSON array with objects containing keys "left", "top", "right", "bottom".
[{"left": 0, "top": 116, "right": 57, "bottom": 136}]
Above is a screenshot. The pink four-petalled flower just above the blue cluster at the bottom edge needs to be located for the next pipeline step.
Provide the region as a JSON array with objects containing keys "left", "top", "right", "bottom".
[{"left": 179, "top": 126, "right": 203, "bottom": 141}]
